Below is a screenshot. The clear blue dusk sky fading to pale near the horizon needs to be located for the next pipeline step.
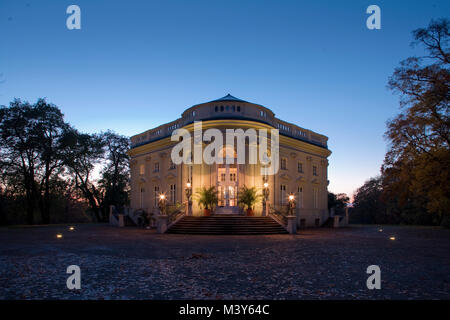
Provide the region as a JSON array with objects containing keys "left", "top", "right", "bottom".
[{"left": 0, "top": 0, "right": 450, "bottom": 199}]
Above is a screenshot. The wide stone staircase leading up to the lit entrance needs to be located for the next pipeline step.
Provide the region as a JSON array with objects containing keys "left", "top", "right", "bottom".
[{"left": 167, "top": 214, "right": 288, "bottom": 235}]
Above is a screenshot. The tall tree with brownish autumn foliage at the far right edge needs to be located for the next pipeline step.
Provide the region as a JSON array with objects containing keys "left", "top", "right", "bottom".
[{"left": 382, "top": 19, "right": 450, "bottom": 228}]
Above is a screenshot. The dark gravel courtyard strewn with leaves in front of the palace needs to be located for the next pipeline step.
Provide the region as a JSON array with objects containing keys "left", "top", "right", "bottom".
[{"left": 0, "top": 224, "right": 450, "bottom": 299}]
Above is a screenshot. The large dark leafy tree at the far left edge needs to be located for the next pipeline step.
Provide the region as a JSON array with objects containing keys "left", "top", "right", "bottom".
[{"left": 0, "top": 99, "right": 68, "bottom": 224}]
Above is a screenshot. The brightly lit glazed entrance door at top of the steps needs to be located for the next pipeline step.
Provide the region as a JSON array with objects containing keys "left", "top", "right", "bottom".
[{"left": 217, "top": 164, "right": 238, "bottom": 207}]
